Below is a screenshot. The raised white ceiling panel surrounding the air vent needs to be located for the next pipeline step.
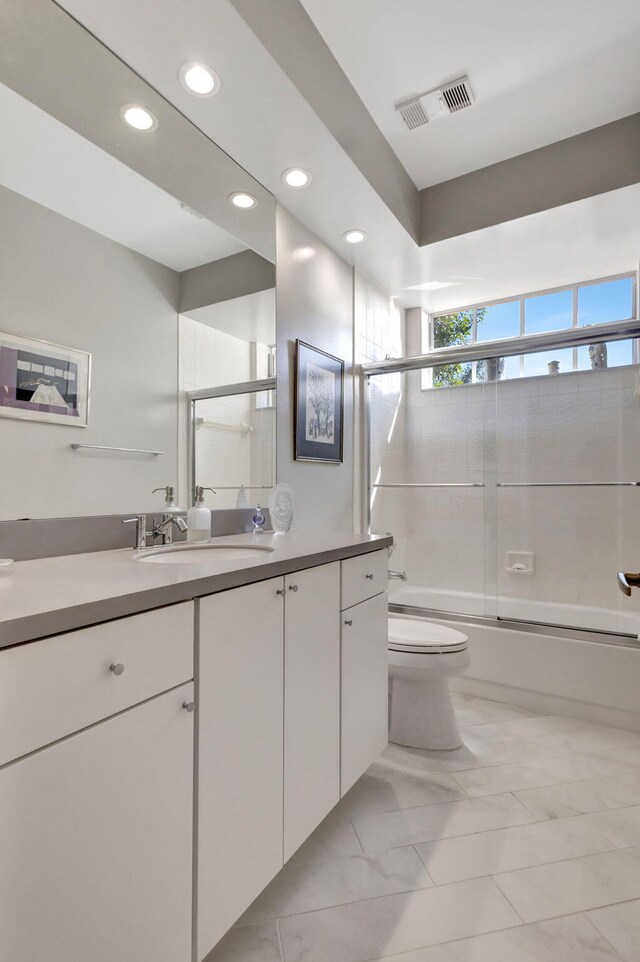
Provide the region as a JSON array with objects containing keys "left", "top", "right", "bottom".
[{"left": 301, "top": 0, "right": 640, "bottom": 188}]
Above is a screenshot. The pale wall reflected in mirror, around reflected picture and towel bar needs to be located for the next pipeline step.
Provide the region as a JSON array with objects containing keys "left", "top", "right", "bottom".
[{"left": 0, "top": 188, "right": 178, "bottom": 519}]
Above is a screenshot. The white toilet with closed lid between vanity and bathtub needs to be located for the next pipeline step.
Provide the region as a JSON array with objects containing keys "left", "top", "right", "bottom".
[{"left": 389, "top": 616, "right": 470, "bottom": 751}]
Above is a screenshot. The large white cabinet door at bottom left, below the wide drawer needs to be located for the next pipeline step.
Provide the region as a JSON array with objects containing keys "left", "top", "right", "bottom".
[{"left": 0, "top": 684, "right": 193, "bottom": 962}]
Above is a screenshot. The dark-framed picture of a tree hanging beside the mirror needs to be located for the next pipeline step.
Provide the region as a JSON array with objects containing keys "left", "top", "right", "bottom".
[{"left": 294, "top": 341, "right": 344, "bottom": 463}]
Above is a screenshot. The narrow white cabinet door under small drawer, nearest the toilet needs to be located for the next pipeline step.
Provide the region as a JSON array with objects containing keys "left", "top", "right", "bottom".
[{"left": 341, "top": 592, "right": 389, "bottom": 795}]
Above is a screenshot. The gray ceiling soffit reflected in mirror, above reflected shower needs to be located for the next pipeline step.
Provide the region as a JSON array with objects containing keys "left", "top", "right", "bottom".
[{"left": 178, "top": 251, "right": 276, "bottom": 314}]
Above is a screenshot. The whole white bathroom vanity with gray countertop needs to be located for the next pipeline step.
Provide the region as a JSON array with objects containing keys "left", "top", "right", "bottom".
[{"left": 0, "top": 534, "right": 390, "bottom": 962}]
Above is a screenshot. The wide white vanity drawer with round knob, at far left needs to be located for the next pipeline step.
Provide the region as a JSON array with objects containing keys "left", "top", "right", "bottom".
[{"left": 0, "top": 601, "right": 193, "bottom": 764}]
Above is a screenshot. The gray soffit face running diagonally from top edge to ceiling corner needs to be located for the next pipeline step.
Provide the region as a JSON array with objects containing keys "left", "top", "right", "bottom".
[{"left": 230, "top": 0, "right": 420, "bottom": 242}]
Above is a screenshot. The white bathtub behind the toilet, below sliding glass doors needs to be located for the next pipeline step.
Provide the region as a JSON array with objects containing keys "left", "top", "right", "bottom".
[{"left": 389, "top": 582, "right": 640, "bottom": 731}]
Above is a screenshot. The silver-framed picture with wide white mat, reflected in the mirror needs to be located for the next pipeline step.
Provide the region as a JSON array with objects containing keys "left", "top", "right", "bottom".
[{"left": 0, "top": 331, "right": 91, "bottom": 428}]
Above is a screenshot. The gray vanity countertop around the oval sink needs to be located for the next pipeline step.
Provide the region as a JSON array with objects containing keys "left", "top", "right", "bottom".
[{"left": 0, "top": 532, "right": 392, "bottom": 648}]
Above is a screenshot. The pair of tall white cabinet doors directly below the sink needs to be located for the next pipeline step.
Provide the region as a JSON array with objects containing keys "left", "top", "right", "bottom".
[{"left": 196, "top": 562, "right": 340, "bottom": 960}]
